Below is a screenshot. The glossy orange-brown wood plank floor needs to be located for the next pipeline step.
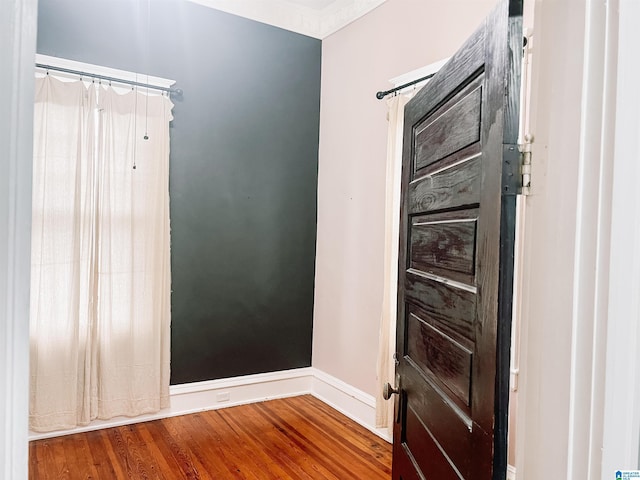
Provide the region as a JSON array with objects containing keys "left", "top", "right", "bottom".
[{"left": 29, "top": 395, "right": 391, "bottom": 480}]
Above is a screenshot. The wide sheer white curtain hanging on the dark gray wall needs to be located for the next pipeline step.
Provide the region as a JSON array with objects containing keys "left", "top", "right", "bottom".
[{"left": 30, "top": 75, "right": 173, "bottom": 431}]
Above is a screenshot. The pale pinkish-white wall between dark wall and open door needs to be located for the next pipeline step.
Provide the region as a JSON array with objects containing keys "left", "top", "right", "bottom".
[{"left": 313, "top": 0, "right": 496, "bottom": 395}]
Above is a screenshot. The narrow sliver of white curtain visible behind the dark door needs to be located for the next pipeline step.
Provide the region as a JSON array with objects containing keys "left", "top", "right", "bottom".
[{"left": 376, "top": 92, "right": 414, "bottom": 435}]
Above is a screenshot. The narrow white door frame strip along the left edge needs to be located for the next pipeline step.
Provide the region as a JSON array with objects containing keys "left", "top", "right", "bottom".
[{"left": 0, "top": 0, "right": 38, "bottom": 480}]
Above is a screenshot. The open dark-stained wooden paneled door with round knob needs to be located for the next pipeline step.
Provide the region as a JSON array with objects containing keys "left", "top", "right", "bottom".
[{"left": 393, "top": 0, "right": 522, "bottom": 480}]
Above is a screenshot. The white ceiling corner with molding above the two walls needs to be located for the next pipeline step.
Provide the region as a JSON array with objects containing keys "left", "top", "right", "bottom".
[{"left": 191, "top": 0, "right": 386, "bottom": 39}]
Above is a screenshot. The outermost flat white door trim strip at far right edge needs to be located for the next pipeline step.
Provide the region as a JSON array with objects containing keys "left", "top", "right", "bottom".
[{"left": 596, "top": 0, "right": 640, "bottom": 472}]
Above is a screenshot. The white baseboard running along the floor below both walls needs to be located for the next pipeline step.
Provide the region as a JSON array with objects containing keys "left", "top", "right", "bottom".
[{"left": 29, "top": 367, "right": 391, "bottom": 442}]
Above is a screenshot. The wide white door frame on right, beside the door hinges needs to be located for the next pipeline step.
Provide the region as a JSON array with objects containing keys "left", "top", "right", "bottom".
[{"left": 516, "top": 0, "right": 640, "bottom": 480}]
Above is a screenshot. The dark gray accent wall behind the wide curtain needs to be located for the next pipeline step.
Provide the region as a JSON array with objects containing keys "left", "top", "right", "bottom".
[{"left": 38, "top": 0, "right": 321, "bottom": 384}]
